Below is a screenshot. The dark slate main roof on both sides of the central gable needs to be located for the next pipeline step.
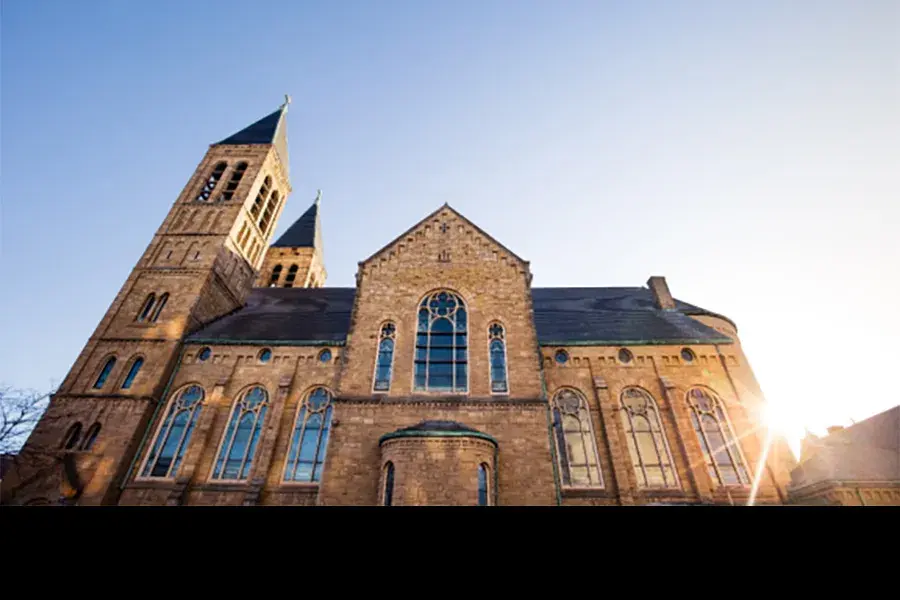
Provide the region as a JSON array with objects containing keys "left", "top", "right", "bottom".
[{"left": 188, "top": 287, "right": 732, "bottom": 345}]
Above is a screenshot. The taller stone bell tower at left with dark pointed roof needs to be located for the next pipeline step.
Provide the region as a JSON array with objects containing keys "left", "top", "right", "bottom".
[{"left": 2, "top": 98, "right": 291, "bottom": 504}]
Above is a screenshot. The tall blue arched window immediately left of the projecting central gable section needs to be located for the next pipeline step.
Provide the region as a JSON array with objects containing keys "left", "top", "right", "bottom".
[{"left": 284, "top": 387, "right": 331, "bottom": 482}]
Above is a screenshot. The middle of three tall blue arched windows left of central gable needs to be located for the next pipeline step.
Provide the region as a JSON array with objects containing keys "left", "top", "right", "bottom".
[{"left": 212, "top": 386, "right": 269, "bottom": 481}]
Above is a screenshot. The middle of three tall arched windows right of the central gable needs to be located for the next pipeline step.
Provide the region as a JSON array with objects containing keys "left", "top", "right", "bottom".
[{"left": 621, "top": 387, "right": 678, "bottom": 487}]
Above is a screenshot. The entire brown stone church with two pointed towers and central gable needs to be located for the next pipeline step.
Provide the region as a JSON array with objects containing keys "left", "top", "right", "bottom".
[{"left": 2, "top": 103, "right": 793, "bottom": 506}]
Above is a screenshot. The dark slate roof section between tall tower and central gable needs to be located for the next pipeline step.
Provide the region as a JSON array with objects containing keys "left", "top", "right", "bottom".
[{"left": 187, "top": 288, "right": 356, "bottom": 345}]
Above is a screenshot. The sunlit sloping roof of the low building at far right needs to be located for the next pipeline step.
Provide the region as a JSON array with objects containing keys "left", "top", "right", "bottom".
[{"left": 791, "top": 406, "right": 900, "bottom": 488}]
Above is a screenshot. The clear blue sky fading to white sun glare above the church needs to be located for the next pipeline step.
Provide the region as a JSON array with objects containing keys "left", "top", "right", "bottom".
[{"left": 0, "top": 0, "right": 900, "bottom": 450}]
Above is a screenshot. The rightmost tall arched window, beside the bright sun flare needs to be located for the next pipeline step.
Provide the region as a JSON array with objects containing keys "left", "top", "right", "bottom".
[{"left": 687, "top": 388, "right": 750, "bottom": 485}]
